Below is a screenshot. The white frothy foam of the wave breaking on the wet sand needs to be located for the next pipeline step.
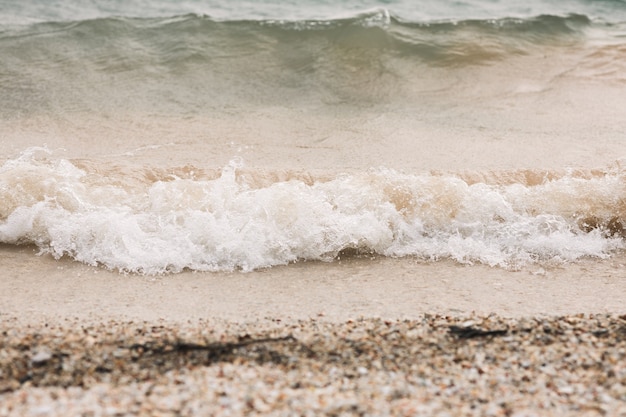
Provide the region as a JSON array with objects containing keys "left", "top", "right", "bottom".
[{"left": 0, "top": 149, "right": 624, "bottom": 274}]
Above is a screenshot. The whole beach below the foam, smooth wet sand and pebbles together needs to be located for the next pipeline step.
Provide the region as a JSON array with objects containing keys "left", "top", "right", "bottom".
[{"left": 0, "top": 247, "right": 626, "bottom": 416}]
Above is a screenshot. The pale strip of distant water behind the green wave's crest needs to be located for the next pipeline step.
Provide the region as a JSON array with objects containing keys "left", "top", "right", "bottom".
[{"left": 0, "top": 0, "right": 626, "bottom": 23}]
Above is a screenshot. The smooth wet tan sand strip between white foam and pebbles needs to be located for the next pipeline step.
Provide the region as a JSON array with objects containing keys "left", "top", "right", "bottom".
[{"left": 0, "top": 245, "right": 626, "bottom": 324}]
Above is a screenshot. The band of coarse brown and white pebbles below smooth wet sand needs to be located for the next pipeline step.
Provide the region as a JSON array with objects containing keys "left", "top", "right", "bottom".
[{"left": 0, "top": 314, "right": 626, "bottom": 417}]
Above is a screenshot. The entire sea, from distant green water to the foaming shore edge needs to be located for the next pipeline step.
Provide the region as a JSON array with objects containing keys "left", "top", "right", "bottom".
[{"left": 0, "top": 0, "right": 626, "bottom": 274}]
